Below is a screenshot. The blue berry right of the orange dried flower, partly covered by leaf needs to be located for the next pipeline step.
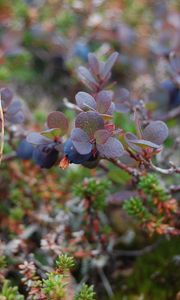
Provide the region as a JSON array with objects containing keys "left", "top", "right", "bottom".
[{"left": 64, "top": 139, "right": 92, "bottom": 164}]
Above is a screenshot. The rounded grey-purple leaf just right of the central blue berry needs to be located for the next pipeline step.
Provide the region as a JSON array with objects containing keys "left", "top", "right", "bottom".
[{"left": 97, "top": 137, "right": 124, "bottom": 158}]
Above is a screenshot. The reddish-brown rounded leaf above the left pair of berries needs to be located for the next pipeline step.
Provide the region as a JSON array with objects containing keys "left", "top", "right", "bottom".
[{"left": 47, "top": 111, "right": 68, "bottom": 134}]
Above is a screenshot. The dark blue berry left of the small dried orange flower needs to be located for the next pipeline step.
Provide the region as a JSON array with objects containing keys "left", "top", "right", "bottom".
[{"left": 33, "top": 143, "right": 59, "bottom": 169}]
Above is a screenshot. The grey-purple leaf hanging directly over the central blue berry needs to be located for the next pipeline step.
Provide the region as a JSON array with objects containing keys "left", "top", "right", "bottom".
[{"left": 71, "top": 128, "right": 92, "bottom": 155}]
